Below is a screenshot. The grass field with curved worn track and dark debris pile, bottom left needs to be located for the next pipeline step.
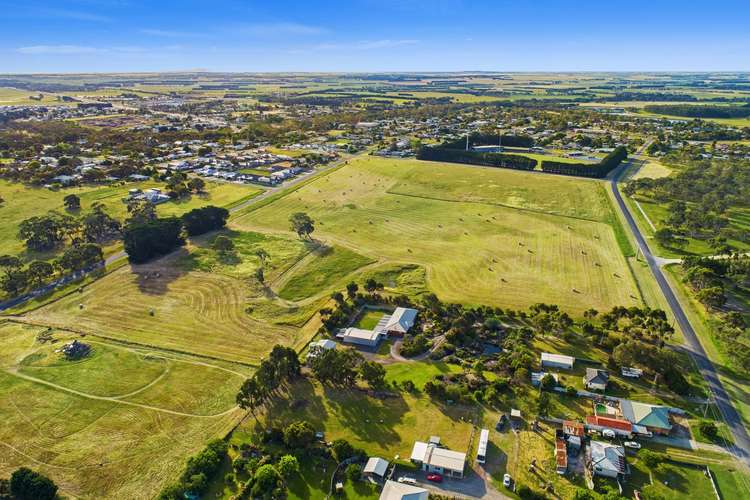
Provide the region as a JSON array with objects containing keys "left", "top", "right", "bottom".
[{"left": 0, "top": 323, "right": 249, "bottom": 499}]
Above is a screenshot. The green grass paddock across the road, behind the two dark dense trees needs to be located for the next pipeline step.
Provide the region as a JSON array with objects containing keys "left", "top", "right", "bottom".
[{"left": 0, "top": 180, "right": 261, "bottom": 254}]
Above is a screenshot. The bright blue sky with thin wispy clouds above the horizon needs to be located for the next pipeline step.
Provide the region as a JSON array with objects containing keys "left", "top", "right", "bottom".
[{"left": 0, "top": 0, "right": 750, "bottom": 73}]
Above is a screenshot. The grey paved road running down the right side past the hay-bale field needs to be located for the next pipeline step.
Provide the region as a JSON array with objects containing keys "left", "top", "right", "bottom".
[{"left": 611, "top": 162, "right": 750, "bottom": 465}]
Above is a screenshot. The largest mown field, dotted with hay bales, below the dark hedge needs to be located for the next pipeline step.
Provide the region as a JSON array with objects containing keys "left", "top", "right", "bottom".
[{"left": 231, "top": 158, "right": 640, "bottom": 313}]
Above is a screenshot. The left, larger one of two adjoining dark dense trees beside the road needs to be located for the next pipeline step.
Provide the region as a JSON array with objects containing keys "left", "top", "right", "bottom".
[{"left": 123, "top": 217, "right": 185, "bottom": 264}]
